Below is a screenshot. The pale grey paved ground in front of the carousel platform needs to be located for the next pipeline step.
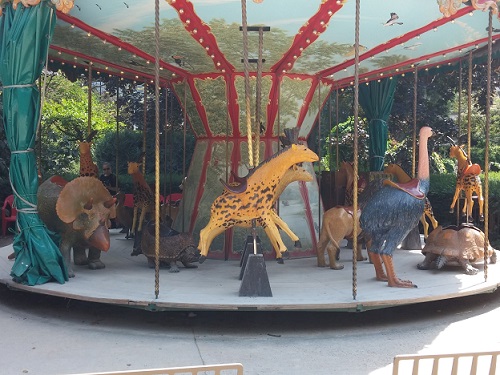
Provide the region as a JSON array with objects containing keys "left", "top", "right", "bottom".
[{"left": 0, "top": 274, "right": 500, "bottom": 375}]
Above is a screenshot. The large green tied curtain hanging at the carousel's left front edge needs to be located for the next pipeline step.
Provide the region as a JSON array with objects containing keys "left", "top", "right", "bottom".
[{"left": 0, "top": 0, "right": 68, "bottom": 285}]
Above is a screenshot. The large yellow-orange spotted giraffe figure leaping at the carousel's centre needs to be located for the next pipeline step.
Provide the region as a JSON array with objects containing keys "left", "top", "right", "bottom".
[{"left": 198, "top": 144, "right": 318, "bottom": 263}]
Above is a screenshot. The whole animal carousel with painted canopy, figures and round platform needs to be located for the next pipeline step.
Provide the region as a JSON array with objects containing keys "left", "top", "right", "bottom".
[{"left": 0, "top": 0, "right": 500, "bottom": 311}]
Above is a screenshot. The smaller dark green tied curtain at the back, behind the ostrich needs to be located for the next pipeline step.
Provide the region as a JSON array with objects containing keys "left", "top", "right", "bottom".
[{"left": 359, "top": 77, "right": 397, "bottom": 171}]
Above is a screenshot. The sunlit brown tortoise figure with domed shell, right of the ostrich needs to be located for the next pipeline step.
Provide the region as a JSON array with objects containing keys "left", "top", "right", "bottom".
[{"left": 417, "top": 224, "right": 497, "bottom": 275}]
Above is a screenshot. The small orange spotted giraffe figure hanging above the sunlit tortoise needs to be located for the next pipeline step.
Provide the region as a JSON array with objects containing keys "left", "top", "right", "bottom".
[{"left": 450, "top": 145, "right": 484, "bottom": 221}]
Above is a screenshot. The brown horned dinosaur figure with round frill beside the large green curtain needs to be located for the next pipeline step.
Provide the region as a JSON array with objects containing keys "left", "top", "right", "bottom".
[{"left": 38, "top": 176, "right": 116, "bottom": 277}]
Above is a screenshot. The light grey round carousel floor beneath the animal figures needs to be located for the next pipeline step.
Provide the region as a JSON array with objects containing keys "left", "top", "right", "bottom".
[{"left": 0, "top": 230, "right": 500, "bottom": 312}]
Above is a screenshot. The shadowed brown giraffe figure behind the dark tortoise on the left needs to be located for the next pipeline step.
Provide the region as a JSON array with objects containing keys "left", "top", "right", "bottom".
[{"left": 128, "top": 161, "right": 155, "bottom": 256}]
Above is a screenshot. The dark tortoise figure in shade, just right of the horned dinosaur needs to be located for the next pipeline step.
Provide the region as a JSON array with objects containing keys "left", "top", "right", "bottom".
[{"left": 141, "top": 220, "right": 200, "bottom": 273}]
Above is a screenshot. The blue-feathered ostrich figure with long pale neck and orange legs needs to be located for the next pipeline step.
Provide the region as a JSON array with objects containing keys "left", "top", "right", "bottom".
[{"left": 360, "top": 126, "right": 433, "bottom": 288}]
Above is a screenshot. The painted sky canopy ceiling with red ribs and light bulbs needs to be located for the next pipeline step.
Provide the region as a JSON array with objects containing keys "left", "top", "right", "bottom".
[{"left": 49, "top": 0, "right": 500, "bottom": 87}]
